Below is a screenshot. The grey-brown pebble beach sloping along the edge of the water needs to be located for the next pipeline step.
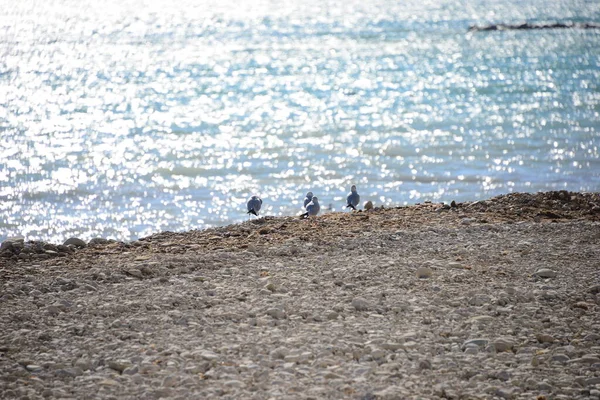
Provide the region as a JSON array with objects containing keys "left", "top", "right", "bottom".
[{"left": 0, "top": 191, "right": 600, "bottom": 400}]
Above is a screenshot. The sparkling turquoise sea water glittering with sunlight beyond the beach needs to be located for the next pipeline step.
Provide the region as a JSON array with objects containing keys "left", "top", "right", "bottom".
[{"left": 0, "top": 0, "right": 600, "bottom": 242}]
